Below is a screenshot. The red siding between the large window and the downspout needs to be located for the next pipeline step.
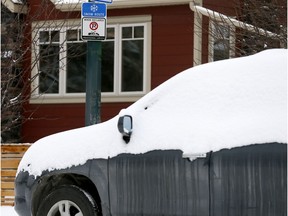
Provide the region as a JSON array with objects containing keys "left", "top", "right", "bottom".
[{"left": 151, "top": 5, "right": 194, "bottom": 88}]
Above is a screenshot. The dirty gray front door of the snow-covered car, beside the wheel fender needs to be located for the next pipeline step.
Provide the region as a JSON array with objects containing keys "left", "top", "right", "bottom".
[{"left": 109, "top": 150, "right": 209, "bottom": 216}]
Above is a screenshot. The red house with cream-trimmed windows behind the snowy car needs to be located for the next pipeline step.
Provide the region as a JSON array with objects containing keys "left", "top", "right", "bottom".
[{"left": 2, "top": 0, "right": 287, "bottom": 142}]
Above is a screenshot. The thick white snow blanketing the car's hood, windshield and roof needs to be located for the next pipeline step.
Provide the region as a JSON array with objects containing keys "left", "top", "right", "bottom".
[{"left": 18, "top": 49, "right": 287, "bottom": 176}]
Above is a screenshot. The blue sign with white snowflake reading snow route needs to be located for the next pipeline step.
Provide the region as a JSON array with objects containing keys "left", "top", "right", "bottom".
[{"left": 82, "top": 2, "right": 107, "bottom": 18}]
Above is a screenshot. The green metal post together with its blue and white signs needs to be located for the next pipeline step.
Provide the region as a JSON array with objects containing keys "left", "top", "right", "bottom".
[{"left": 81, "top": 0, "right": 112, "bottom": 126}]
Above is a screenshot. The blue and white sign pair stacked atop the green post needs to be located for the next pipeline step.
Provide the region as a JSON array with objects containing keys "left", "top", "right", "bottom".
[{"left": 81, "top": 1, "right": 110, "bottom": 41}]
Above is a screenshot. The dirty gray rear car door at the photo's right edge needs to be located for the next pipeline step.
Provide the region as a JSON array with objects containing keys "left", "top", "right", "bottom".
[{"left": 210, "top": 143, "right": 287, "bottom": 216}]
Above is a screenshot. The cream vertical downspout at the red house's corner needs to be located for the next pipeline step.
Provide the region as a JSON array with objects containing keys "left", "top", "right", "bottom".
[{"left": 189, "top": 0, "right": 203, "bottom": 66}]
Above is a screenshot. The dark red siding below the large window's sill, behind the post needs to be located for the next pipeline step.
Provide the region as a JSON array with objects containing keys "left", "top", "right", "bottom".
[{"left": 22, "top": 103, "right": 130, "bottom": 142}]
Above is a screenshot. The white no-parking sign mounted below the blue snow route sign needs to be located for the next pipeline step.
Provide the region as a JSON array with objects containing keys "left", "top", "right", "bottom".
[{"left": 82, "top": 17, "right": 106, "bottom": 40}]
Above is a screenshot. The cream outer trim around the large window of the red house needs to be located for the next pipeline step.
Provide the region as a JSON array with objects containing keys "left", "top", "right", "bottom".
[{"left": 30, "top": 15, "right": 152, "bottom": 104}]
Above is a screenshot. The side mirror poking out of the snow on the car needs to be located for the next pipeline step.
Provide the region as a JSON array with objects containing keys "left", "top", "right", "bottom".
[{"left": 118, "top": 115, "right": 133, "bottom": 143}]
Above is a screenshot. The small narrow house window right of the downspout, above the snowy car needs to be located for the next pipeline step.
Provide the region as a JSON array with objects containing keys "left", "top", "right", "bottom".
[{"left": 209, "top": 21, "right": 235, "bottom": 62}]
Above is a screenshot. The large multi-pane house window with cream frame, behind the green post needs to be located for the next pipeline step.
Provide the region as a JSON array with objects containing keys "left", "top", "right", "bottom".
[{"left": 30, "top": 15, "right": 151, "bottom": 103}]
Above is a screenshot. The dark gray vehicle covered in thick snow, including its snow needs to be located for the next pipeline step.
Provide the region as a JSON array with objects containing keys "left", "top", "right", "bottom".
[{"left": 15, "top": 50, "right": 287, "bottom": 216}]
